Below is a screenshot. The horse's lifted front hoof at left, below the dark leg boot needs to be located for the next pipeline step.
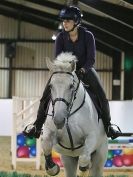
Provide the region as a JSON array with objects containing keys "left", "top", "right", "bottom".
[{"left": 45, "top": 164, "right": 60, "bottom": 176}]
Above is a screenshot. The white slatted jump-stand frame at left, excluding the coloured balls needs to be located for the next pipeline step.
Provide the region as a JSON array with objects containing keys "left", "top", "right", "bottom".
[{"left": 11, "top": 97, "right": 41, "bottom": 169}]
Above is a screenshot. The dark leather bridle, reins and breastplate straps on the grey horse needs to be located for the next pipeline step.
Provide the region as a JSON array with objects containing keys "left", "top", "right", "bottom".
[{"left": 50, "top": 71, "right": 86, "bottom": 151}]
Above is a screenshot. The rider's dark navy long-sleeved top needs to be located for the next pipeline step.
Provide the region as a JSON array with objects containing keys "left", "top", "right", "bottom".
[{"left": 55, "top": 27, "right": 96, "bottom": 72}]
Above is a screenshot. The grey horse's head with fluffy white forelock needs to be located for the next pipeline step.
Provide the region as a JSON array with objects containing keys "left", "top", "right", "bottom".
[{"left": 47, "top": 53, "right": 77, "bottom": 129}]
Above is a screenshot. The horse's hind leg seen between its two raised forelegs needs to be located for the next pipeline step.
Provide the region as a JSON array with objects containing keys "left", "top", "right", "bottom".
[{"left": 61, "top": 155, "right": 78, "bottom": 177}]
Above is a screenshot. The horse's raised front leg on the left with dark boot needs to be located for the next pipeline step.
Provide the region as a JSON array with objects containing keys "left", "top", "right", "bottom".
[{"left": 42, "top": 128, "right": 60, "bottom": 176}]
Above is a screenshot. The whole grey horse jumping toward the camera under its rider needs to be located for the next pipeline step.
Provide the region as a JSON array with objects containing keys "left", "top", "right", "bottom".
[{"left": 42, "top": 52, "right": 108, "bottom": 177}]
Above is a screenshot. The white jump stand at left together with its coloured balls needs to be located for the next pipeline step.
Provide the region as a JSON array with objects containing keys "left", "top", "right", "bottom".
[{"left": 11, "top": 97, "right": 41, "bottom": 169}]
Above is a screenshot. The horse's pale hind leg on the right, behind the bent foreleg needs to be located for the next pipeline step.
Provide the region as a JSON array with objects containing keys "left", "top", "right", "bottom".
[{"left": 90, "top": 141, "right": 108, "bottom": 177}]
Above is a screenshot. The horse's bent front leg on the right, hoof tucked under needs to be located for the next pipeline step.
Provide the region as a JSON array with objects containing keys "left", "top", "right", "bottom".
[{"left": 79, "top": 132, "right": 97, "bottom": 171}]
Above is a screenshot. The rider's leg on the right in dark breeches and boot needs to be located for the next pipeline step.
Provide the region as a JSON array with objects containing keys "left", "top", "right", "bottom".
[{"left": 83, "top": 68, "right": 120, "bottom": 139}]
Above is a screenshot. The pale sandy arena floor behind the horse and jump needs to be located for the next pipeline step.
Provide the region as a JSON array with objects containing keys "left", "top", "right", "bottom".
[{"left": 0, "top": 136, "right": 133, "bottom": 177}]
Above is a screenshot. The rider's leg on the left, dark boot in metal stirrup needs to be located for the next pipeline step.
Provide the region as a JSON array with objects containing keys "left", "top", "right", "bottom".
[{"left": 23, "top": 81, "right": 51, "bottom": 138}]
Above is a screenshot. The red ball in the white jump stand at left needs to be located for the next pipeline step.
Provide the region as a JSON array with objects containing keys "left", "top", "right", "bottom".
[{"left": 17, "top": 146, "right": 30, "bottom": 158}]
